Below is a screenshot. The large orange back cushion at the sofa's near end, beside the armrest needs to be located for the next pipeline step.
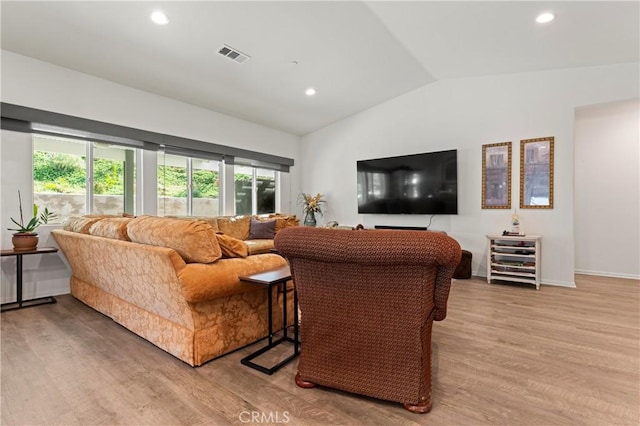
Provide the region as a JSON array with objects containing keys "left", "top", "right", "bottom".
[{"left": 127, "top": 216, "right": 222, "bottom": 263}]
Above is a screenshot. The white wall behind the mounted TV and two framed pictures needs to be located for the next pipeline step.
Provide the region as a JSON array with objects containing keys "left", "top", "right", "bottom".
[{"left": 300, "top": 63, "right": 639, "bottom": 286}]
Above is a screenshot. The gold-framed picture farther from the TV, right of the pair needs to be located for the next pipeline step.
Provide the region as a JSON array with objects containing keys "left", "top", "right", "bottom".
[{"left": 520, "top": 136, "right": 554, "bottom": 209}]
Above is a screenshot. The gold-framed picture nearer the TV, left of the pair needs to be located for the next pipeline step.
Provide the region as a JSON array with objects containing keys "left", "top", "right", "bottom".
[{"left": 482, "top": 142, "right": 511, "bottom": 209}]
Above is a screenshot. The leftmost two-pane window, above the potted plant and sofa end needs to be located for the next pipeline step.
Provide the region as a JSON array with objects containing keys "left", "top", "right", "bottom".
[{"left": 33, "top": 135, "right": 135, "bottom": 223}]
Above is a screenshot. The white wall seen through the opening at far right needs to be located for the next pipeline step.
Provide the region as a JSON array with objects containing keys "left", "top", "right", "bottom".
[{"left": 575, "top": 100, "right": 640, "bottom": 278}]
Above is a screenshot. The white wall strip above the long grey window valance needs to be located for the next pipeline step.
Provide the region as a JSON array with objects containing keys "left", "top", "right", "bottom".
[{"left": 1, "top": 50, "right": 300, "bottom": 212}]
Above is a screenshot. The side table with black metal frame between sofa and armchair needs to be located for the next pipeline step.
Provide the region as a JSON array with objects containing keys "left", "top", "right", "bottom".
[{"left": 240, "top": 266, "right": 300, "bottom": 374}]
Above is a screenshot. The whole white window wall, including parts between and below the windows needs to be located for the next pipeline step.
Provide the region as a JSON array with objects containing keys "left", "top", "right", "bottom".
[{"left": 0, "top": 50, "right": 300, "bottom": 303}]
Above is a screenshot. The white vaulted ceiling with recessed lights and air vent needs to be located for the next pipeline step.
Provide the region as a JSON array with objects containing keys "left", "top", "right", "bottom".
[{"left": 0, "top": 1, "right": 640, "bottom": 135}]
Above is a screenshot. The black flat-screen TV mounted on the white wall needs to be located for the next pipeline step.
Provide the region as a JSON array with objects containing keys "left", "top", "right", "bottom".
[{"left": 357, "top": 149, "right": 458, "bottom": 214}]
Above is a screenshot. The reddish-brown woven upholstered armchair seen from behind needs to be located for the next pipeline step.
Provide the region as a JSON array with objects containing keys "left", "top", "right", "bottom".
[{"left": 275, "top": 227, "right": 461, "bottom": 413}]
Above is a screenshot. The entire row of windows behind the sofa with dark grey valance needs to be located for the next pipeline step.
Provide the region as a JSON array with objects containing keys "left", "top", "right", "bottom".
[{"left": 13, "top": 102, "right": 294, "bottom": 221}]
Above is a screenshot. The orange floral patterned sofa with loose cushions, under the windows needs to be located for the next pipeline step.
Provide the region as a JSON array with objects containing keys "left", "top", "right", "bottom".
[{"left": 52, "top": 216, "right": 296, "bottom": 366}]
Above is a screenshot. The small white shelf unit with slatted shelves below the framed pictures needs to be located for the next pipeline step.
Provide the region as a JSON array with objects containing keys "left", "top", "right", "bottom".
[{"left": 487, "top": 235, "right": 542, "bottom": 290}]
